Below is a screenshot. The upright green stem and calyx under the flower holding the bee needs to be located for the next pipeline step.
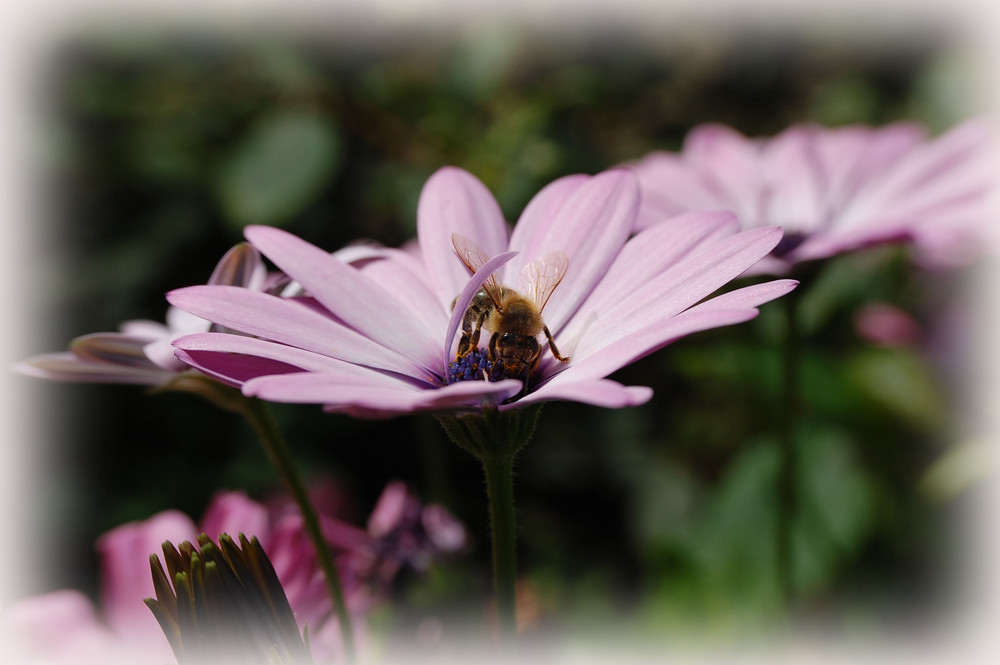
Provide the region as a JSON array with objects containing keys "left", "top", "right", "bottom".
[{"left": 438, "top": 405, "right": 541, "bottom": 645}]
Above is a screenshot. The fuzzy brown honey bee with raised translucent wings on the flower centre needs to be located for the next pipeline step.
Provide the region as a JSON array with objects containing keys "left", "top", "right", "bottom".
[{"left": 451, "top": 233, "right": 569, "bottom": 379}]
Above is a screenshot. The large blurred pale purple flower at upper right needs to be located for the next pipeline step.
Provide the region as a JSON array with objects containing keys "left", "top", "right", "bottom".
[{"left": 634, "top": 120, "right": 998, "bottom": 274}]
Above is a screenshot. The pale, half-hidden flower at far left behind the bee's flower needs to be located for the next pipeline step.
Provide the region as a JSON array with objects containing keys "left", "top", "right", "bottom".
[{"left": 15, "top": 243, "right": 267, "bottom": 385}]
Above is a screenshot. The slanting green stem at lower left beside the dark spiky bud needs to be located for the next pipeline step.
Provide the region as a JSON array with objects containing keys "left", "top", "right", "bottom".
[{"left": 242, "top": 398, "right": 357, "bottom": 664}]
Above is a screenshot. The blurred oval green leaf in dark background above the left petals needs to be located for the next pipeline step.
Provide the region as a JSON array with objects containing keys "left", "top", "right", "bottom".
[{"left": 218, "top": 110, "right": 340, "bottom": 226}]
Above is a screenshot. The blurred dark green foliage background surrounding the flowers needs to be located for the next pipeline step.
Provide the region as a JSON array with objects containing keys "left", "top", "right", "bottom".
[{"left": 13, "top": 3, "right": 1000, "bottom": 660}]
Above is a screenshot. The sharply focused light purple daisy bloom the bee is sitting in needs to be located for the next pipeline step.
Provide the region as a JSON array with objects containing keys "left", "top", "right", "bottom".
[{"left": 168, "top": 167, "right": 795, "bottom": 417}]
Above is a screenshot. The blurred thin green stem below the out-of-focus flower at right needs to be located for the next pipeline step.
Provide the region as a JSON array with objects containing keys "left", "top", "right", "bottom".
[{"left": 776, "top": 282, "right": 801, "bottom": 607}]
